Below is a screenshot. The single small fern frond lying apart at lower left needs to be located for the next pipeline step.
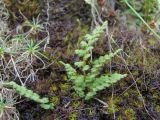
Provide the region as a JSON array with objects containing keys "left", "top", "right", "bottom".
[{"left": 2, "top": 81, "right": 53, "bottom": 109}]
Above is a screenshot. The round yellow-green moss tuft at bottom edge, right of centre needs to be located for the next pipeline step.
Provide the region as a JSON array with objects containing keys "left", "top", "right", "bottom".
[{"left": 124, "top": 108, "right": 136, "bottom": 120}]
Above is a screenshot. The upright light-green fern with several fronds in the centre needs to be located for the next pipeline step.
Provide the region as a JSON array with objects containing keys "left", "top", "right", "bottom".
[{"left": 60, "top": 22, "right": 126, "bottom": 100}]
